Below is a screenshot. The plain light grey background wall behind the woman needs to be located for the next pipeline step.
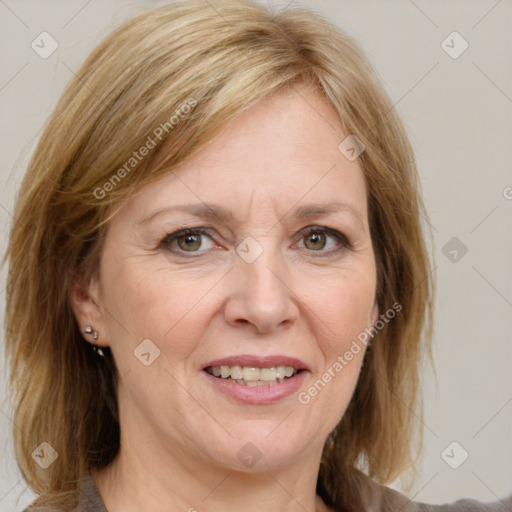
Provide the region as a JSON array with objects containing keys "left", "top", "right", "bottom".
[{"left": 0, "top": 0, "right": 512, "bottom": 512}]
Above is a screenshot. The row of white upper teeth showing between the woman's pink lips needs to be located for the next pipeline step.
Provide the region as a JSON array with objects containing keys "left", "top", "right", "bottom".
[{"left": 207, "top": 365, "right": 298, "bottom": 386}]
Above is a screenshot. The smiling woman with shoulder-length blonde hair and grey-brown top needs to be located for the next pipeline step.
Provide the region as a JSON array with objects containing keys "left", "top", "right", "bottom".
[{"left": 6, "top": 1, "right": 511, "bottom": 512}]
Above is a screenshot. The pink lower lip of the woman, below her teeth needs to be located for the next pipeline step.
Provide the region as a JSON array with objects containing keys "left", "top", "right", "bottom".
[{"left": 203, "top": 370, "right": 308, "bottom": 405}]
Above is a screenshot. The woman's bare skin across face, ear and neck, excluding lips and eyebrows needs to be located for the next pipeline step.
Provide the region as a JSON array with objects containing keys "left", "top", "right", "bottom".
[{"left": 71, "top": 86, "right": 378, "bottom": 512}]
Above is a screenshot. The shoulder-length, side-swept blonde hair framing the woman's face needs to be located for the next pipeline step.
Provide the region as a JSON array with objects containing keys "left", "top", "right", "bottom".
[{"left": 4, "top": 0, "right": 433, "bottom": 510}]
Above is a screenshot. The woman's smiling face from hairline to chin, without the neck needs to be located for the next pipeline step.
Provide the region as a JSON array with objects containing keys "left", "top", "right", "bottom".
[{"left": 86, "top": 84, "right": 378, "bottom": 471}]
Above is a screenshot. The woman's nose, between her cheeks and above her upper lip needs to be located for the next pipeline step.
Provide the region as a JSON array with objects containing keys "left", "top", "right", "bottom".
[{"left": 225, "top": 242, "right": 299, "bottom": 334}]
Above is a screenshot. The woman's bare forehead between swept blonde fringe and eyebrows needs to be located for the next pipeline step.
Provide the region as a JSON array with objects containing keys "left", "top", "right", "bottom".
[{"left": 120, "top": 86, "right": 366, "bottom": 224}]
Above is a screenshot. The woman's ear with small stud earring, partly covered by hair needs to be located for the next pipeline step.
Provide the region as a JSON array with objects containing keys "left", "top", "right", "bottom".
[{"left": 69, "top": 274, "right": 108, "bottom": 347}]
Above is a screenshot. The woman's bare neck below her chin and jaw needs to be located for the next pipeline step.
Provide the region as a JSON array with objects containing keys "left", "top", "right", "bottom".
[{"left": 92, "top": 432, "right": 327, "bottom": 512}]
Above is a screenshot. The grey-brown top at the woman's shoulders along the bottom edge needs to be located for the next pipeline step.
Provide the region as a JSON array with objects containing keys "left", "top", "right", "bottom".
[{"left": 24, "top": 475, "right": 512, "bottom": 512}]
